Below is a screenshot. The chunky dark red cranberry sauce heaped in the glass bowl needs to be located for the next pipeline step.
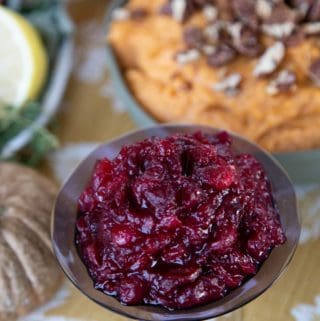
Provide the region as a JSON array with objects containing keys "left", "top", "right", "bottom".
[{"left": 75, "top": 132, "right": 285, "bottom": 309}]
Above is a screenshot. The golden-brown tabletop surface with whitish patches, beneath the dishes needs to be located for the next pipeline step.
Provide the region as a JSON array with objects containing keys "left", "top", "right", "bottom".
[{"left": 33, "top": 0, "right": 320, "bottom": 321}]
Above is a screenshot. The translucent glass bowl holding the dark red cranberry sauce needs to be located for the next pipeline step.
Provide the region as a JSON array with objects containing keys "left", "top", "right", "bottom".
[{"left": 52, "top": 125, "right": 300, "bottom": 321}]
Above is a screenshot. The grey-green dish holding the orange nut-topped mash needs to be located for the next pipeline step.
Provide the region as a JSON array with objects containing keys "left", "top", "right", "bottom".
[{"left": 105, "top": 0, "right": 320, "bottom": 184}]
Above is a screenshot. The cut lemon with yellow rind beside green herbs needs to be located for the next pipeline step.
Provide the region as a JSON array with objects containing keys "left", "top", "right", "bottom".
[{"left": 0, "top": 5, "right": 47, "bottom": 107}]
